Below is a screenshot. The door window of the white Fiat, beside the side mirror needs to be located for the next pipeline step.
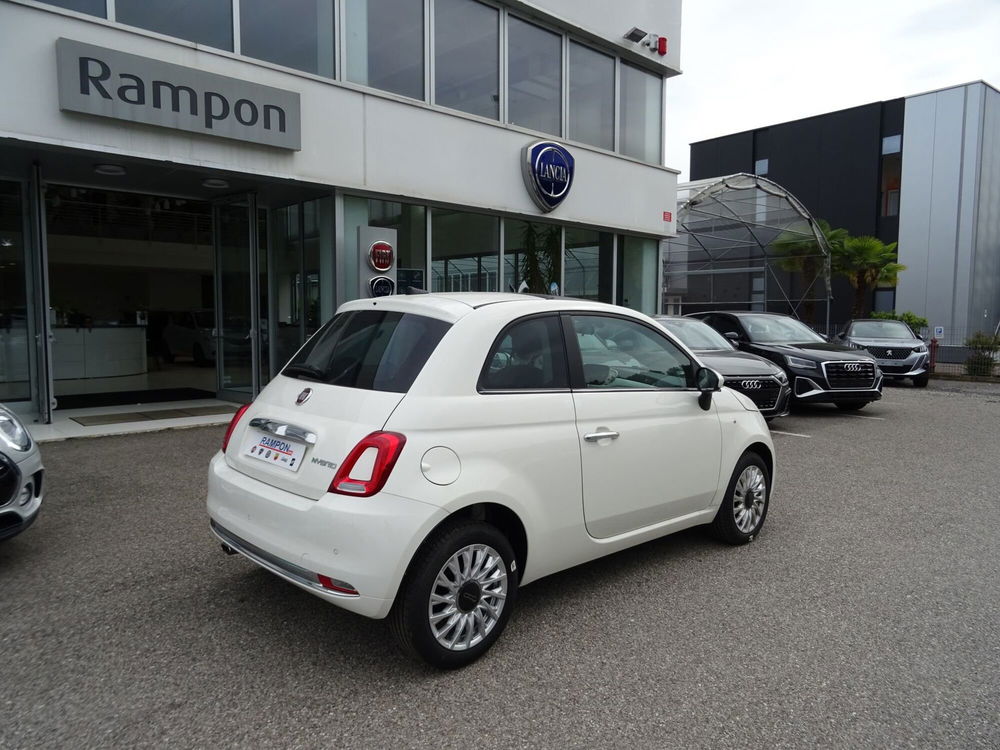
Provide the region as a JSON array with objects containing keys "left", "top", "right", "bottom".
[{"left": 572, "top": 315, "right": 694, "bottom": 389}]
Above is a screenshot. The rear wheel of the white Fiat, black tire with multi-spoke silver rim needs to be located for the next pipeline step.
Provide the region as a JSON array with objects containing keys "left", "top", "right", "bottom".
[{"left": 389, "top": 521, "right": 520, "bottom": 669}]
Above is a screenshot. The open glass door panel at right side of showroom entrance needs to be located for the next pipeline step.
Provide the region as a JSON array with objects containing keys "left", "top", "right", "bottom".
[{"left": 213, "top": 194, "right": 261, "bottom": 402}]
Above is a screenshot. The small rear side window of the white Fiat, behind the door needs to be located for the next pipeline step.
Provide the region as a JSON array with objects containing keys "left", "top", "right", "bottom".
[{"left": 479, "top": 315, "right": 569, "bottom": 391}]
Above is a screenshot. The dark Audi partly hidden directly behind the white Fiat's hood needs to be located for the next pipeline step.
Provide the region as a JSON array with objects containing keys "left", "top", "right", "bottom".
[{"left": 653, "top": 315, "right": 791, "bottom": 419}]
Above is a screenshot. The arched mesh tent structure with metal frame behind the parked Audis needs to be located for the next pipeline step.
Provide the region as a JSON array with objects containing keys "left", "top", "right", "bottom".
[{"left": 663, "top": 173, "right": 830, "bottom": 326}]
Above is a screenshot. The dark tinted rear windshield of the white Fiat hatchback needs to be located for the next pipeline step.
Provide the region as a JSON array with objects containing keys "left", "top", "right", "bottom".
[{"left": 281, "top": 310, "right": 451, "bottom": 393}]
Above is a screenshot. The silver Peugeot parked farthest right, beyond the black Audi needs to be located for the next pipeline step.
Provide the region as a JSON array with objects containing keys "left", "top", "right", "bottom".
[{"left": 837, "top": 318, "right": 930, "bottom": 388}]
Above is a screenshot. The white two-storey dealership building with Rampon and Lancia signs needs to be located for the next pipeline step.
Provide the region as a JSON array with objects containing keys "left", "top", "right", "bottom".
[{"left": 0, "top": 0, "right": 680, "bottom": 422}]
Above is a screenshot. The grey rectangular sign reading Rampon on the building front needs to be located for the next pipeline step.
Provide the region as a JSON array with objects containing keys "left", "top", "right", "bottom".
[{"left": 56, "top": 39, "right": 302, "bottom": 151}]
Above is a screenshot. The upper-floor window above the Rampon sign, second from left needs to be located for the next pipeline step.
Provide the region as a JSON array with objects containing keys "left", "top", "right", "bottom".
[{"left": 115, "top": 0, "right": 233, "bottom": 51}]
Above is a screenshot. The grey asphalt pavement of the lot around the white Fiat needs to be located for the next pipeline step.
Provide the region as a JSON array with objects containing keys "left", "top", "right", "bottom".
[{"left": 0, "top": 382, "right": 1000, "bottom": 748}]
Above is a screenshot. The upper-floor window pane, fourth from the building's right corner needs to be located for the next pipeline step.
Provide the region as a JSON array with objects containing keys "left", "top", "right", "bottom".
[{"left": 434, "top": 0, "right": 500, "bottom": 120}]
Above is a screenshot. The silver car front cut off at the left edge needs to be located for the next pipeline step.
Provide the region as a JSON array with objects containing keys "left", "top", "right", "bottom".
[{"left": 0, "top": 404, "right": 44, "bottom": 539}]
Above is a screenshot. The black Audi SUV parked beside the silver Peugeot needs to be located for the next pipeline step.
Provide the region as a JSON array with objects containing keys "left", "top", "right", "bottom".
[{"left": 688, "top": 311, "right": 882, "bottom": 411}]
